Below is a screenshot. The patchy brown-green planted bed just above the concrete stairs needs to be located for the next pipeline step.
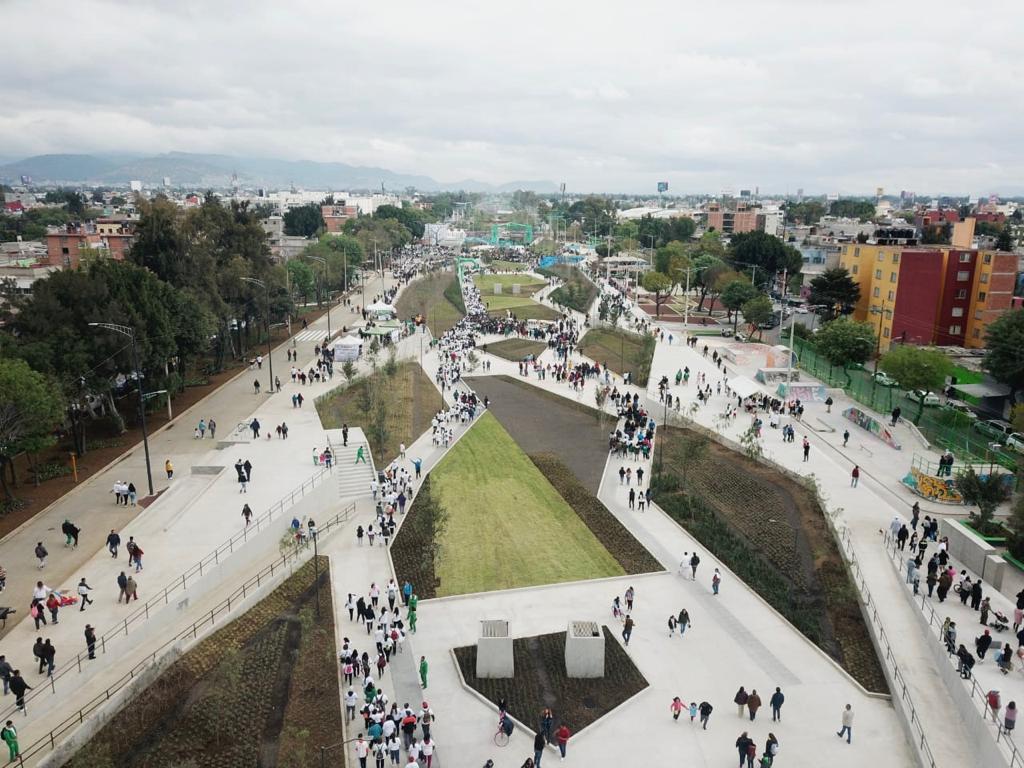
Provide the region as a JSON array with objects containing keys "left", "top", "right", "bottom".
[{"left": 316, "top": 355, "right": 441, "bottom": 467}]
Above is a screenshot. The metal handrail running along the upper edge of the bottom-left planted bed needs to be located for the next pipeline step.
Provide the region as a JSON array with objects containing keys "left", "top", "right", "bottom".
[{"left": 5, "top": 502, "right": 355, "bottom": 766}]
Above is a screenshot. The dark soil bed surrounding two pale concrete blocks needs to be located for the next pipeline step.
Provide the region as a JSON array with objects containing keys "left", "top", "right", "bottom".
[{"left": 455, "top": 627, "right": 648, "bottom": 737}]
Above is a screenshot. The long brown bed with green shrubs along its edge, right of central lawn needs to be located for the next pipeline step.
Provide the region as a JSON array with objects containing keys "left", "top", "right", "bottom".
[{"left": 651, "top": 428, "right": 888, "bottom": 692}]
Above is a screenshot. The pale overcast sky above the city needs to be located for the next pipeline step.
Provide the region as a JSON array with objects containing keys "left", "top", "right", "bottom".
[{"left": 0, "top": 0, "right": 1024, "bottom": 195}]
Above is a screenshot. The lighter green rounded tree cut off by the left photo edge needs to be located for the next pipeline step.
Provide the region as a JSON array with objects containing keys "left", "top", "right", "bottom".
[{"left": 0, "top": 357, "right": 63, "bottom": 501}]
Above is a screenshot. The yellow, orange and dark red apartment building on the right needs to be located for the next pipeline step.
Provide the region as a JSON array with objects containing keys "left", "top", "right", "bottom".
[{"left": 840, "top": 243, "right": 1017, "bottom": 350}]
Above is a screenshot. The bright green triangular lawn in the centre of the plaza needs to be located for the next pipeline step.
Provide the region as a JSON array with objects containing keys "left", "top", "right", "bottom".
[{"left": 430, "top": 414, "right": 625, "bottom": 597}]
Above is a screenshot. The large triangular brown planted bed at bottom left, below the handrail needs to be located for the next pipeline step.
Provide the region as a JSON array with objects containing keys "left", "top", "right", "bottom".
[{"left": 65, "top": 557, "right": 341, "bottom": 768}]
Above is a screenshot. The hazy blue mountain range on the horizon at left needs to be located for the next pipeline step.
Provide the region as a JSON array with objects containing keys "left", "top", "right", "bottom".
[{"left": 0, "top": 152, "right": 557, "bottom": 193}]
